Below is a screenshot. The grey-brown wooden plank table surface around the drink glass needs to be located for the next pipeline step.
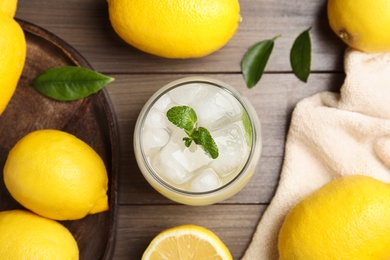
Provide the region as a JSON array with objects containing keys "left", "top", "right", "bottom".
[{"left": 16, "top": 0, "right": 345, "bottom": 259}]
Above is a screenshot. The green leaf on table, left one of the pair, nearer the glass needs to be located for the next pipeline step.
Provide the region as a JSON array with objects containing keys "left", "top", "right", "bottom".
[{"left": 241, "top": 35, "right": 280, "bottom": 88}]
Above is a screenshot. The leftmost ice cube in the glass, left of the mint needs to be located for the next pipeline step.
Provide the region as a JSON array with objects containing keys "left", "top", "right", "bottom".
[{"left": 142, "top": 127, "right": 169, "bottom": 156}]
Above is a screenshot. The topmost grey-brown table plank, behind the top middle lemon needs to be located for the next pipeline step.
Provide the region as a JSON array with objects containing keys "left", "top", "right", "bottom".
[{"left": 16, "top": 0, "right": 345, "bottom": 73}]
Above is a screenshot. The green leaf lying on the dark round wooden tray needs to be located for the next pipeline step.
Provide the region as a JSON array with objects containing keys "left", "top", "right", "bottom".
[{"left": 31, "top": 66, "right": 114, "bottom": 101}]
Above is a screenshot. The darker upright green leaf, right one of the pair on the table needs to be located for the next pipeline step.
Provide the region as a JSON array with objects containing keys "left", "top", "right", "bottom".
[{"left": 290, "top": 28, "right": 311, "bottom": 82}]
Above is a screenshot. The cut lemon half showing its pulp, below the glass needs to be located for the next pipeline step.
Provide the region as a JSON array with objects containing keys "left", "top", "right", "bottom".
[{"left": 142, "top": 225, "right": 232, "bottom": 260}]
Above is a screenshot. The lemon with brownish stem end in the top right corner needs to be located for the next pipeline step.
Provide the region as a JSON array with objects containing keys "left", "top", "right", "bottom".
[{"left": 328, "top": 0, "right": 390, "bottom": 52}]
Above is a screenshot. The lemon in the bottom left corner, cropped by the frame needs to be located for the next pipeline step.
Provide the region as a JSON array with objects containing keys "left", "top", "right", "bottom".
[{"left": 0, "top": 210, "right": 79, "bottom": 260}]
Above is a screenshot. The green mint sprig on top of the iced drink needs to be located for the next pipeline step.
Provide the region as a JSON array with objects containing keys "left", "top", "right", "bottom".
[{"left": 167, "top": 106, "right": 219, "bottom": 159}]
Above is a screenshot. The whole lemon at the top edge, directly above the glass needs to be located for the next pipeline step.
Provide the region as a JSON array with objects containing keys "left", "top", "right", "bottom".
[{"left": 108, "top": 0, "right": 241, "bottom": 58}]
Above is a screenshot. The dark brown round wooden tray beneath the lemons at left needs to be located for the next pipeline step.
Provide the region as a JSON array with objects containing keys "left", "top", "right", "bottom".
[{"left": 0, "top": 20, "right": 119, "bottom": 260}]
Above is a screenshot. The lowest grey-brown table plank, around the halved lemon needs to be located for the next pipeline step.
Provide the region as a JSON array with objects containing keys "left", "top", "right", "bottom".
[{"left": 114, "top": 205, "right": 265, "bottom": 260}]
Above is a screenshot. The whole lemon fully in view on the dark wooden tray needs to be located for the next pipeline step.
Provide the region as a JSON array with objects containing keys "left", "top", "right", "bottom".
[{"left": 4, "top": 129, "right": 108, "bottom": 220}]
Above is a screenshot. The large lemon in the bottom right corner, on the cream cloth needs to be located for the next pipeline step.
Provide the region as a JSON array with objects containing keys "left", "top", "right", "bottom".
[{"left": 278, "top": 175, "right": 390, "bottom": 260}]
